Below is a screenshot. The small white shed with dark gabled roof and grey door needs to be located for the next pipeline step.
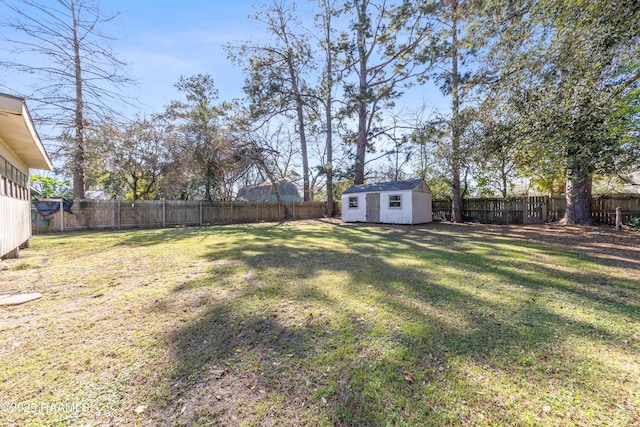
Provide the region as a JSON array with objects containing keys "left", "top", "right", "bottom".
[{"left": 342, "top": 179, "right": 433, "bottom": 224}]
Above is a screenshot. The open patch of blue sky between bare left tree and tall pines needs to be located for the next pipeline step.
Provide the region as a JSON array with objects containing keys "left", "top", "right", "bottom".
[{"left": 109, "top": 0, "right": 262, "bottom": 113}]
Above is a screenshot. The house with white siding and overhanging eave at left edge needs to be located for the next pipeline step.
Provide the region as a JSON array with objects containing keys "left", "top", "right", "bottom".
[{"left": 0, "top": 93, "right": 52, "bottom": 258}]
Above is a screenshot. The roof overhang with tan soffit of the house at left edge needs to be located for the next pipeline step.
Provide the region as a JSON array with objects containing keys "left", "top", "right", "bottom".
[{"left": 0, "top": 93, "right": 53, "bottom": 170}]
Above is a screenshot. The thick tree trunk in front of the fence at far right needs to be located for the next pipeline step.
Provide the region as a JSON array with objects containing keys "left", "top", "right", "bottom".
[{"left": 561, "top": 167, "right": 594, "bottom": 225}]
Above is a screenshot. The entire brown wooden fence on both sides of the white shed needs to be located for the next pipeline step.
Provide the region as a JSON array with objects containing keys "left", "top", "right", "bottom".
[{"left": 32, "top": 194, "right": 640, "bottom": 232}]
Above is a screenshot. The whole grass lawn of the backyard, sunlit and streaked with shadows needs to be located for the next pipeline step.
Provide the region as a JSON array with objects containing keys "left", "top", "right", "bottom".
[{"left": 0, "top": 221, "right": 640, "bottom": 426}]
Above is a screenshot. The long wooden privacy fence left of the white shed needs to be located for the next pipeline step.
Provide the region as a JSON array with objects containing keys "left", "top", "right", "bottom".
[{"left": 32, "top": 200, "right": 327, "bottom": 233}]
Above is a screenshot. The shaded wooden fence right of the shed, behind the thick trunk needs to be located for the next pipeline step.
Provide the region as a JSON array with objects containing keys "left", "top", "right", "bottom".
[{"left": 433, "top": 194, "right": 640, "bottom": 225}]
